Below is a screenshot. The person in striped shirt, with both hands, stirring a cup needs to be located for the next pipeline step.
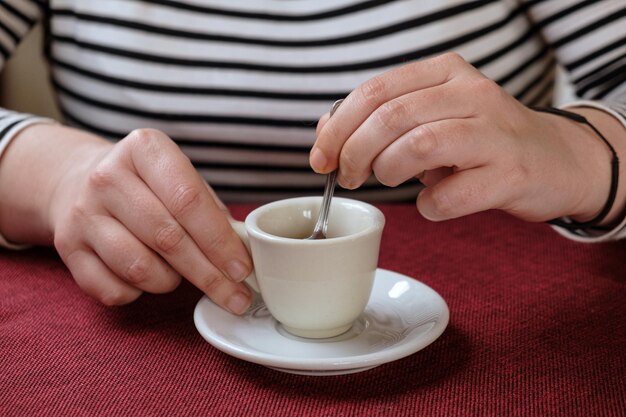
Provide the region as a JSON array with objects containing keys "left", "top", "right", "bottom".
[{"left": 0, "top": 0, "right": 626, "bottom": 313}]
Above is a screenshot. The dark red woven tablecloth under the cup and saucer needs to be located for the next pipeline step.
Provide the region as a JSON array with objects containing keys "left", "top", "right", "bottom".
[{"left": 0, "top": 205, "right": 626, "bottom": 416}]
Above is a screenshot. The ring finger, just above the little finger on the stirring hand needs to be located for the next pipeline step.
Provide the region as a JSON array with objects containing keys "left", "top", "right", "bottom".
[{"left": 372, "top": 119, "right": 492, "bottom": 187}]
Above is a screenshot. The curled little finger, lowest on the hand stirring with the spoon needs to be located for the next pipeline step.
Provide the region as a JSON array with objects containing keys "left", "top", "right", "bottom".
[{"left": 417, "top": 167, "right": 511, "bottom": 221}]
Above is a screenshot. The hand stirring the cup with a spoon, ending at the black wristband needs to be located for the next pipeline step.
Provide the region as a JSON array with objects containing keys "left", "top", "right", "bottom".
[{"left": 310, "top": 53, "right": 611, "bottom": 221}]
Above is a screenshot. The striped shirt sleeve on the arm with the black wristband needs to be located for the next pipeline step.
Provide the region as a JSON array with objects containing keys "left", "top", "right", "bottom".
[{"left": 527, "top": 0, "right": 626, "bottom": 242}]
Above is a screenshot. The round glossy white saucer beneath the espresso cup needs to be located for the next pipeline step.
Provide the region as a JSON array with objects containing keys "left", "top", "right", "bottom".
[{"left": 194, "top": 269, "right": 449, "bottom": 375}]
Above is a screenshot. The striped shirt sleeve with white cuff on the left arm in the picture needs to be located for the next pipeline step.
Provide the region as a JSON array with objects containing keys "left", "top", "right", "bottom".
[{"left": 0, "top": 0, "right": 54, "bottom": 249}]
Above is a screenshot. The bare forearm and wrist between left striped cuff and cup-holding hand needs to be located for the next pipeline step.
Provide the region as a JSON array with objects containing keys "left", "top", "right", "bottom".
[{"left": 0, "top": 124, "right": 112, "bottom": 245}]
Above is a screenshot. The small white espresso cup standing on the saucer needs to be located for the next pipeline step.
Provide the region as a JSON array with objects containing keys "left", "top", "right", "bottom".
[{"left": 233, "top": 197, "right": 385, "bottom": 338}]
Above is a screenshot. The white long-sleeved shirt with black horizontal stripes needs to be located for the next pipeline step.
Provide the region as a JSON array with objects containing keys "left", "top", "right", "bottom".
[{"left": 0, "top": 0, "right": 626, "bottom": 239}]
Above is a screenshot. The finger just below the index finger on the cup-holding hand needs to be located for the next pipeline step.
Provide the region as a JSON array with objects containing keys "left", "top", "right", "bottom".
[{"left": 91, "top": 158, "right": 251, "bottom": 314}]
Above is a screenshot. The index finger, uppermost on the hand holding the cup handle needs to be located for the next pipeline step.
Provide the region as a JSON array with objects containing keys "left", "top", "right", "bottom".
[{"left": 122, "top": 130, "right": 252, "bottom": 281}]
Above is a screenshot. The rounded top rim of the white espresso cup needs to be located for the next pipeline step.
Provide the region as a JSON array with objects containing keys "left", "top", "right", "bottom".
[{"left": 244, "top": 196, "right": 385, "bottom": 245}]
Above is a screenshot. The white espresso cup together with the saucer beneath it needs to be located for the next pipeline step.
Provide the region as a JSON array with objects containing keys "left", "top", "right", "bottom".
[{"left": 194, "top": 197, "right": 449, "bottom": 376}]
